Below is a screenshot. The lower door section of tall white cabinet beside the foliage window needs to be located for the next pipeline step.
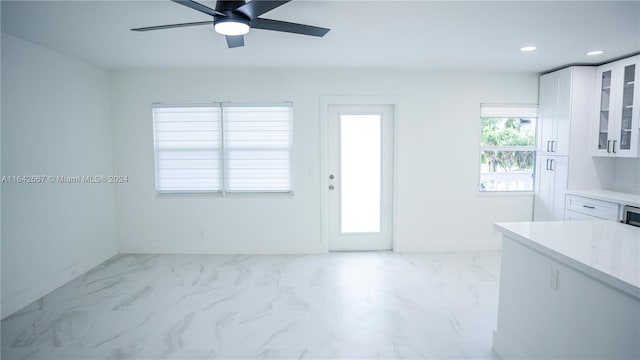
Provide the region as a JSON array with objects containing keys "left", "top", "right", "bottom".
[{"left": 533, "top": 156, "right": 569, "bottom": 221}]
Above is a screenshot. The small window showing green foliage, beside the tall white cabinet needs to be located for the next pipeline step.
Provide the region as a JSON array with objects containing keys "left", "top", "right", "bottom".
[{"left": 479, "top": 104, "right": 537, "bottom": 191}]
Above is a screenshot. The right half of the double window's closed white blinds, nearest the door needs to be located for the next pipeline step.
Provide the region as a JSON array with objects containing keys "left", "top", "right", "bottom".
[{"left": 222, "top": 104, "right": 292, "bottom": 193}]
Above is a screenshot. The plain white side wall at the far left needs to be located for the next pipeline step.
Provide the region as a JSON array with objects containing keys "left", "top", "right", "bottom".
[{"left": 2, "top": 33, "right": 117, "bottom": 318}]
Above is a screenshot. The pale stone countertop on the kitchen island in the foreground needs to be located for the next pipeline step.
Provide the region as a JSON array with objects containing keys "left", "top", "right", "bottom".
[{"left": 494, "top": 220, "right": 640, "bottom": 299}]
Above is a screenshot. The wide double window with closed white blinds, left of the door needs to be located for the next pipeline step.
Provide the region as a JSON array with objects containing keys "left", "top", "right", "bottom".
[{"left": 153, "top": 103, "right": 292, "bottom": 194}]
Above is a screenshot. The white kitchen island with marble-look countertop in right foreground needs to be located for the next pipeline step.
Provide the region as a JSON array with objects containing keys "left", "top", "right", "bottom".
[{"left": 493, "top": 220, "right": 640, "bottom": 359}]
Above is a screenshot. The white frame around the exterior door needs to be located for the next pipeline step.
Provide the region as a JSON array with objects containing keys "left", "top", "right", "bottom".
[{"left": 320, "top": 95, "right": 398, "bottom": 252}]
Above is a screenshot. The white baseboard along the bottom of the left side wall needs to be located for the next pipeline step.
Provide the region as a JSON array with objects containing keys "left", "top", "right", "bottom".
[{"left": 0, "top": 247, "right": 118, "bottom": 320}]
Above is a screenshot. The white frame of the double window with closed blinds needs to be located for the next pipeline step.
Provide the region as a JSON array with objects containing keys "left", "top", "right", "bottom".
[{"left": 151, "top": 101, "right": 294, "bottom": 197}]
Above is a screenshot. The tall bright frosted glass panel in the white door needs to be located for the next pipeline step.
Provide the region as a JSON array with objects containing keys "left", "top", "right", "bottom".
[{"left": 340, "top": 115, "right": 381, "bottom": 233}]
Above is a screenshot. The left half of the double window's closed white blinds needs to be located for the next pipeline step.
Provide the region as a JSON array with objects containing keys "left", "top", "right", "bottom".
[{"left": 153, "top": 106, "right": 222, "bottom": 192}]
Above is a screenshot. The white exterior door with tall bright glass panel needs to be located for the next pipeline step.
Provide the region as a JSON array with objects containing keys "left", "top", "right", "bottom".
[{"left": 326, "top": 105, "right": 394, "bottom": 251}]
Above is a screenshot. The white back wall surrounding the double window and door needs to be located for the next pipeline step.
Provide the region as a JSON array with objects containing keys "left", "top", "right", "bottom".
[{"left": 111, "top": 69, "right": 538, "bottom": 253}]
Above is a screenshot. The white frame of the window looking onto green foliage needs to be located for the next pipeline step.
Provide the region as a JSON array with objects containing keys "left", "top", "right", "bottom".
[{"left": 476, "top": 103, "right": 539, "bottom": 196}]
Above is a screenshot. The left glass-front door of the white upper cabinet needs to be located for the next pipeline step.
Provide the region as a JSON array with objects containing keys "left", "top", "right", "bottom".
[{"left": 593, "top": 64, "right": 614, "bottom": 156}]
